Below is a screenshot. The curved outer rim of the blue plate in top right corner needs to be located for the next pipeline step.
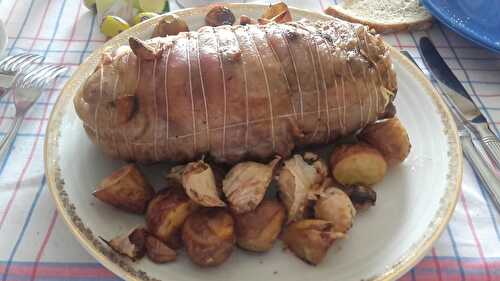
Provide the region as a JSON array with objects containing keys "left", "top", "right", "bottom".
[{"left": 421, "top": 0, "right": 500, "bottom": 53}]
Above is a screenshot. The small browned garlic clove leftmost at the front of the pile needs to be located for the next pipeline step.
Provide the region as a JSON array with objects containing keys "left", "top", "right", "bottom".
[{"left": 99, "top": 227, "right": 148, "bottom": 261}]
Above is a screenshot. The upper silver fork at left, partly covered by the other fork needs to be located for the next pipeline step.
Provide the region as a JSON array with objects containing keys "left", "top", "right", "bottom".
[{"left": 0, "top": 53, "right": 44, "bottom": 98}]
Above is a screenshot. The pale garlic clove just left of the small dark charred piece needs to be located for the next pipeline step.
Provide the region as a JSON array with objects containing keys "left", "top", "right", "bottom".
[{"left": 314, "top": 187, "right": 356, "bottom": 233}]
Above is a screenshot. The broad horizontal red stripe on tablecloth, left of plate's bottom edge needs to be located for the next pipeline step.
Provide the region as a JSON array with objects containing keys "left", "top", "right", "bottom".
[{"left": 0, "top": 264, "right": 115, "bottom": 278}]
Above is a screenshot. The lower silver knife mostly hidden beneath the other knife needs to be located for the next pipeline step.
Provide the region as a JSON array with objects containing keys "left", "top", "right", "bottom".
[{"left": 401, "top": 51, "right": 500, "bottom": 212}]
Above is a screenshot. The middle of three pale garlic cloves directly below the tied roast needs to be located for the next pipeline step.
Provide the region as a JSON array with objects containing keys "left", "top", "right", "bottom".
[{"left": 222, "top": 157, "right": 281, "bottom": 214}]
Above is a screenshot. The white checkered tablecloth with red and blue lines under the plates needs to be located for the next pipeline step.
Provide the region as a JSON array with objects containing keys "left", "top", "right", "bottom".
[{"left": 0, "top": 0, "right": 500, "bottom": 281}]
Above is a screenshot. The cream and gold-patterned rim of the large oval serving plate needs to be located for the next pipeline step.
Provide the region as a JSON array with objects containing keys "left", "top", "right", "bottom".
[{"left": 44, "top": 3, "right": 463, "bottom": 281}]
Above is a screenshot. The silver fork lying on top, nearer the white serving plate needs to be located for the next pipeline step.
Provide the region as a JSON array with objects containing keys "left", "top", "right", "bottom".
[{"left": 0, "top": 65, "right": 66, "bottom": 159}]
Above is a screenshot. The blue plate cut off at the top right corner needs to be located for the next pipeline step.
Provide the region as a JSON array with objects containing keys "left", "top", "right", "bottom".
[{"left": 421, "top": 0, "right": 500, "bottom": 53}]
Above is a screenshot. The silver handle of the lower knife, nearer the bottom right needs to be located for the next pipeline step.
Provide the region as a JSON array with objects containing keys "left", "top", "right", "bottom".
[{"left": 460, "top": 133, "right": 500, "bottom": 212}]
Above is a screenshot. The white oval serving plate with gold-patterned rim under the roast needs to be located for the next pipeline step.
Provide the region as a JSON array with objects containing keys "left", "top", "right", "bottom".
[{"left": 45, "top": 4, "right": 462, "bottom": 281}]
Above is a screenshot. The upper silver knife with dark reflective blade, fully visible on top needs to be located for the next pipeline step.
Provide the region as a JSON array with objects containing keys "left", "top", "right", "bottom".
[{"left": 418, "top": 37, "right": 500, "bottom": 171}]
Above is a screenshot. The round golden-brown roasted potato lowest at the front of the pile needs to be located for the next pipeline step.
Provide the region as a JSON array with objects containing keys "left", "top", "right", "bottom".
[{"left": 182, "top": 208, "right": 236, "bottom": 267}]
